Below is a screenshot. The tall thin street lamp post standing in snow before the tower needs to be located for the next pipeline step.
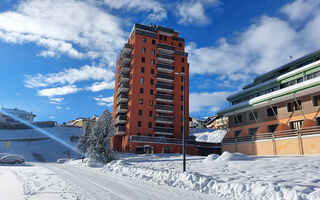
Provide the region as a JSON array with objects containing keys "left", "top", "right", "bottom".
[{"left": 174, "top": 72, "right": 186, "bottom": 172}]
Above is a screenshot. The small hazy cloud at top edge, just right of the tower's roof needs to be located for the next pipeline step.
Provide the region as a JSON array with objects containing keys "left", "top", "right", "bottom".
[{"left": 177, "top": 0, "right": 219, "bottom": 25}]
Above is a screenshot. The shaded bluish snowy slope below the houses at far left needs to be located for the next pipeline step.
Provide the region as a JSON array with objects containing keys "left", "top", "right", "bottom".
[{"left": 0, "top": 126, "right": 82, "bottom": 162}]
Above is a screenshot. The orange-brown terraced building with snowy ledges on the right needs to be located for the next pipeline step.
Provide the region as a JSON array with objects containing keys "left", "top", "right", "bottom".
[{"left": 220, "top": 51, "right": 320, "bottom": 155}]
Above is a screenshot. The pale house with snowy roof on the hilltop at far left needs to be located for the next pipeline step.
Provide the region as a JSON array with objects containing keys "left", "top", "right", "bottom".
[{"left": 0, "top": 108, "right": 36, "bottom": 123}]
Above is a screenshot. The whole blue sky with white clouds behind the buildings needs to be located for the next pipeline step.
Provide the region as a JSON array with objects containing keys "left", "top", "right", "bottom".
[{"left": 0, "top": 0, "right": 320, "bottom": 123}]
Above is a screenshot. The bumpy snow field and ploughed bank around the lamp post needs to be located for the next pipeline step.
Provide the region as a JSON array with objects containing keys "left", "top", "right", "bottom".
[{"left": 103, "top": 152, "right": 320, "bottom": 200}]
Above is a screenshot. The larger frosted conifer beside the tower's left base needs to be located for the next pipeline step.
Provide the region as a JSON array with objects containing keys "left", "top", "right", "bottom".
[{"left": 87, "top": 110, "right": 114, "bottom": 162}]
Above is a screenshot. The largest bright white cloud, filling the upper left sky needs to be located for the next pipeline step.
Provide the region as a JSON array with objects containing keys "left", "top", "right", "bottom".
[{"left": 0, "top": 0, "right": 127, "bottom": 66}]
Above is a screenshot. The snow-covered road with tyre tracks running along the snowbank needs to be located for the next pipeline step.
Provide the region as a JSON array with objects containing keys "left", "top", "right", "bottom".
[{"left": 41, "top": 163, "right": 219, "bottom": 200}]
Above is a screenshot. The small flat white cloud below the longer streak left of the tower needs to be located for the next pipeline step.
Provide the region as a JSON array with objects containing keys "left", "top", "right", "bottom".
[{"left": 38, "top": 85, "right": 81, "bottom": 97}]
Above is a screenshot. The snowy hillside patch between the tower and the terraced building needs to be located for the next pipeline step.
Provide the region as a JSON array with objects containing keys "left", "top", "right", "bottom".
[{"left": 189, "top": 128, "right": 227, "bottom": 143}]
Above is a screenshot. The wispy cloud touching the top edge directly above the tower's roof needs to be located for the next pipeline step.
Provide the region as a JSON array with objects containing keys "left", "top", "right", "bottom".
[{"left": 104, "top": 0, "right": 167, "bottom": 21}]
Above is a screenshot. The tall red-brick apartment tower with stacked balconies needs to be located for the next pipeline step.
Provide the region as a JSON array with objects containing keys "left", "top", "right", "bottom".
[{"left": 112, "top": 24, "right": 189, "bottom": 153}]
